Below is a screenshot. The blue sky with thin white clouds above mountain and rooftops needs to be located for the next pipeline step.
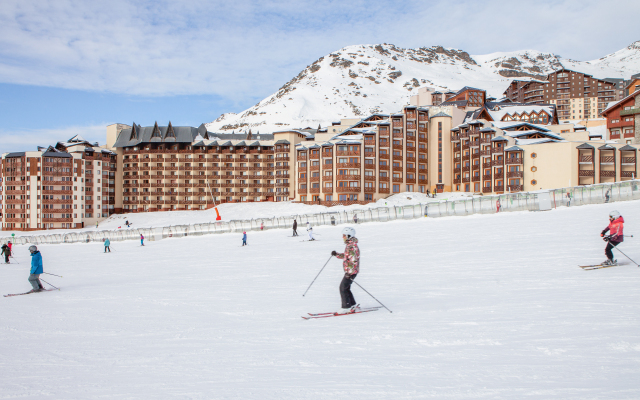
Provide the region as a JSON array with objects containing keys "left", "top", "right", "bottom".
[{"left": 0, "top": 0, "right": 640, "bottom": 152}]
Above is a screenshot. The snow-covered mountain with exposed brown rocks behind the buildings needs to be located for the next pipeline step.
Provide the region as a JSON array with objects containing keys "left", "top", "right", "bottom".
[{"left": 207, "top": 41, "right": 640, "bottom": 133}]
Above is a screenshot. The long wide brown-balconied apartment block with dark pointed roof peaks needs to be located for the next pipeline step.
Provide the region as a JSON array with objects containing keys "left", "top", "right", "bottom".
[{"left": 107, "top": 123, "right": 307, "bottom": 212}]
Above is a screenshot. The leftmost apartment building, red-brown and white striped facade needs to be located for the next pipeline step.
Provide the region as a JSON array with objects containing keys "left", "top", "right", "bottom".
[{"left": 0, "top": 136, "right": 116, "bottom": 231}]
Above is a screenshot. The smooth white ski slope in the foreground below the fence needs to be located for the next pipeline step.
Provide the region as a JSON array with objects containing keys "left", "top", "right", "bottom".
[{"left": 0, "top": 201, "right": 640, "bottom": 399}]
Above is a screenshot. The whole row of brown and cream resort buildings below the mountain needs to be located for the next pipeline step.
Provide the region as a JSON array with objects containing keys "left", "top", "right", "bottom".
[{"left": 0, "top": 69, "right": 640, "bottom": 230}]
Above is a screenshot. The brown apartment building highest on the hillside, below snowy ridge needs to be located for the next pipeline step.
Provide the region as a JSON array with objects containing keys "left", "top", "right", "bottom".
[{"left": 504, "top": 69, "right": 626, "bottom": 121}]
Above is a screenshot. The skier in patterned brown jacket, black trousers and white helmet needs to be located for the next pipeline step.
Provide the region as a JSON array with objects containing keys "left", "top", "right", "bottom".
[{"left": 331, "top": 227, "right": 360, "bottom": 314}]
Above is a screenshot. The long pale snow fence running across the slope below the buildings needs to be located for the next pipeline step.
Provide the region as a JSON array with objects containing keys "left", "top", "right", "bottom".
[{"left": 0, "top": 180, "right": 640, "bottom": 244}]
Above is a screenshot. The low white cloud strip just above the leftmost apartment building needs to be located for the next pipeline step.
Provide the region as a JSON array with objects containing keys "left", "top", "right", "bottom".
[{"left": 0, "top": 123, "right": 107, "bottom": 153}]
